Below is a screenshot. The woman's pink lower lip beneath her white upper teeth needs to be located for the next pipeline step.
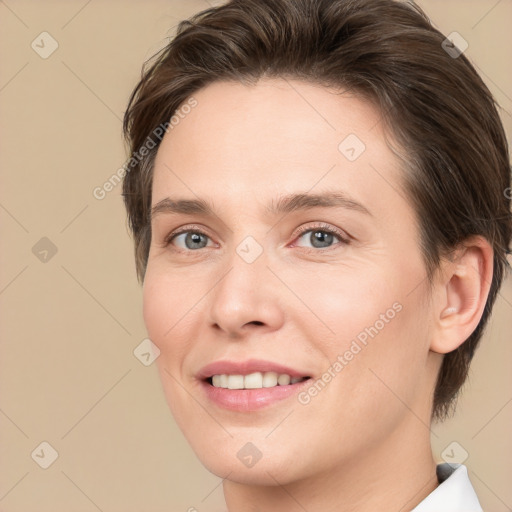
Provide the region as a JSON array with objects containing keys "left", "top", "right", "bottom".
[{"left": 201, "top": 379, "right": 311, "bottom": 412}]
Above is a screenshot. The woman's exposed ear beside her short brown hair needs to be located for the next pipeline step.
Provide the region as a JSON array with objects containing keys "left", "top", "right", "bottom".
[{"left": 430, "top": 236, "right": 494, "bottom": 354}]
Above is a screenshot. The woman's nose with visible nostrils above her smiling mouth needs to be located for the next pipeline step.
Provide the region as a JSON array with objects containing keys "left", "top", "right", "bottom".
[{"left": 208, "top": 244, "right": 284, "bottom": 339}]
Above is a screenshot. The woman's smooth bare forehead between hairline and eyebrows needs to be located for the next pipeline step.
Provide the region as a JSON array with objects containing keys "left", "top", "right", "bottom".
[{"left": 153, "top": 79, "right": 403, "bottom": 221}]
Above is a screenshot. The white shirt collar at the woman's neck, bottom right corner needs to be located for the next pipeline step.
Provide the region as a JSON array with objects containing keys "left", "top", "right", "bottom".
[{"left": 411, "top": 463, "right": 483, "bottom": 512}]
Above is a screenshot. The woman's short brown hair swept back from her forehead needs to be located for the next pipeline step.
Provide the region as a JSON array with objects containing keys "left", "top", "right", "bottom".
[{"left": 123, "top": 0, "right": 511, "bottom": 419}]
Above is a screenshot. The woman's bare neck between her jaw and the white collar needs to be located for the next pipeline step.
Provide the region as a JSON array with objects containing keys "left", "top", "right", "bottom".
[{"left": 223, "top": 415, "right": 438, "bottom": 512}]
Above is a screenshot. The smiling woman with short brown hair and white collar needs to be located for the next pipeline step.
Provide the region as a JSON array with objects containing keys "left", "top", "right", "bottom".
[{"left": 123, "top": 0, "right": 511, "bottom": 512}]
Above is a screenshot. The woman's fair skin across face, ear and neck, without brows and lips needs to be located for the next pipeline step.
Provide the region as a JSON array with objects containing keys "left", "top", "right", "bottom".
[{"left": 143, "top": 79, "right": 492, "bottom": 512}]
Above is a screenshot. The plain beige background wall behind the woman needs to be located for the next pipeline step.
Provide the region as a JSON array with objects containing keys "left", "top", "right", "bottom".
[{"left": 0, "top": 0, "right": 512, "bottom": 512}]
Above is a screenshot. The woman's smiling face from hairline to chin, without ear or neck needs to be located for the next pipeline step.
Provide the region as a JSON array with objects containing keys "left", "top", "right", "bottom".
[{"left": 144, "top": 79, "right": 437, "bottom": 485}]
